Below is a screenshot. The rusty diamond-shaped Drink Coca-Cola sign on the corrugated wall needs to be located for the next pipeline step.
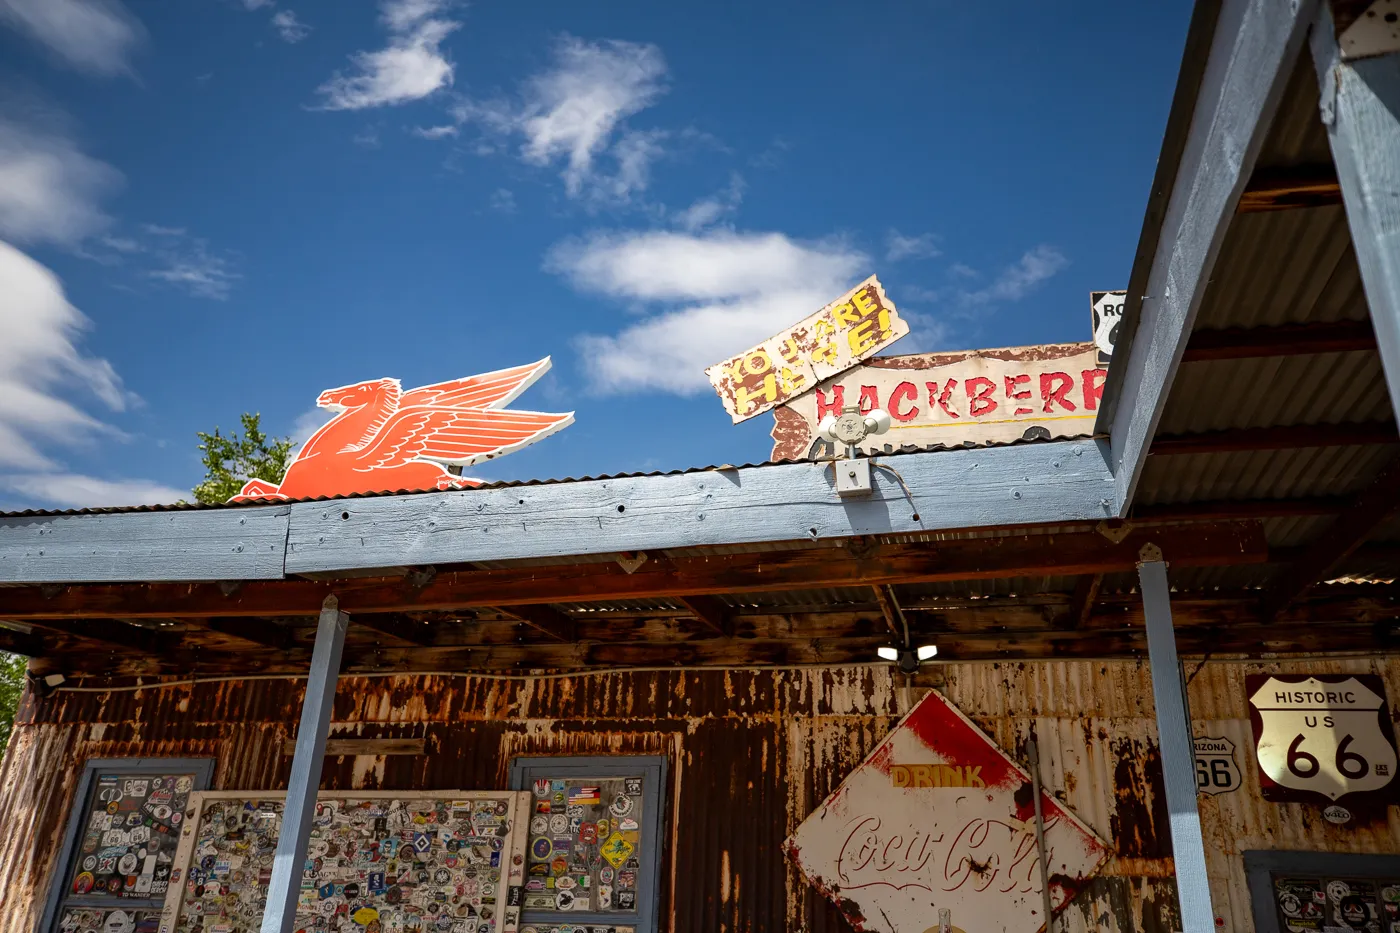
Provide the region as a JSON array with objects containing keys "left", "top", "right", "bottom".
[{"left": 784, "top": 691, "right": 1107, "bottom": 933}]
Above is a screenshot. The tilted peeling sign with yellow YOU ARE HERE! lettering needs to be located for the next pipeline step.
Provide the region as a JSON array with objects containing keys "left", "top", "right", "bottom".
[{"left": 706, "top": 276, "right": 909, "bottom": 423}]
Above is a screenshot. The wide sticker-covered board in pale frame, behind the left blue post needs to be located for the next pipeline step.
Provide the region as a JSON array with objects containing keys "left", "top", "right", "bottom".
[{"left": 160, "top": 790, "right": 529, "bottom": 933}]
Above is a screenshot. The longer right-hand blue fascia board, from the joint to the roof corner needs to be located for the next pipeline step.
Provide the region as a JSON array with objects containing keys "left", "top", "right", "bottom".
[{"left": 287, "top": 440, "right": 1113, "bottom": 574}]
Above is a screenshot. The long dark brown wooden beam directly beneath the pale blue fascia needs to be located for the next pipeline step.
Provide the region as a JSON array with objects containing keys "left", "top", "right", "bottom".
[{"left": 0, "top": 523, "right": 1268, "bottom": 625}]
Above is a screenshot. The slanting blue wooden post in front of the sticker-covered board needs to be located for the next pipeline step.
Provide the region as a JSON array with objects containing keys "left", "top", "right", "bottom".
[{"left": 262, "top": 595, "right": 350, "bottom": 933}]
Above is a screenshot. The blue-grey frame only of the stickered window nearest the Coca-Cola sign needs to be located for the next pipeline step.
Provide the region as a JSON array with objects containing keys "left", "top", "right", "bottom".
[{"left": 510, "top": 755, "right": 669, "bottom": 933}]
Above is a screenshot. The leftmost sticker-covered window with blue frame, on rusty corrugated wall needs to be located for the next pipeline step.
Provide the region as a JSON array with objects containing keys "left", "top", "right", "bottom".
[{"left": 41, "top": 759, "right": 213, "bottom": 933}]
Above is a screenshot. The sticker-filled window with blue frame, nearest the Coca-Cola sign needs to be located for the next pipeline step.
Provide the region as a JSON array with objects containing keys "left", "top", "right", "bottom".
[{"left": 511, "top": 755, "right": 666, "bottom": 933}]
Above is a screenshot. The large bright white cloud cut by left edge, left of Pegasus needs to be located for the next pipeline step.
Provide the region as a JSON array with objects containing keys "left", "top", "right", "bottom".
[{"left": 0, "top": 242, "right": 133, "bottom": 469}]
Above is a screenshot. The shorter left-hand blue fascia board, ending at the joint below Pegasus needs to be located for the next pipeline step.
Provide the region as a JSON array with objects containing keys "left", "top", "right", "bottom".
[{"left": 0, "top": 506, "right": 291, "bottom": 583}]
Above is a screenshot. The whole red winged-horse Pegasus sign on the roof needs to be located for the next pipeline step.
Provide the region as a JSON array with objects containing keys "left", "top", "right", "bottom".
[{"left": 230, "top": 357, "right": 574, "bottom": 502}]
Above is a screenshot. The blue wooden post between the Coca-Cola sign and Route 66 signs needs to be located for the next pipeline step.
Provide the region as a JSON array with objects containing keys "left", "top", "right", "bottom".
[{"left": 1138, "top": 545, "right": 1215, "bottom": 933}]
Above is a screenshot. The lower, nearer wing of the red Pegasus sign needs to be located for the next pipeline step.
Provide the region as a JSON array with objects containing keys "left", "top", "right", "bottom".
[{"left": 354, "top": 408, "right": 574, "bottom": 471}]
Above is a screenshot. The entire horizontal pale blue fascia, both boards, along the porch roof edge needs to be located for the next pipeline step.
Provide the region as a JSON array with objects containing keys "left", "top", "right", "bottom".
[{"left": 0, "top": 440, "right": 1113, "bottom": 582}]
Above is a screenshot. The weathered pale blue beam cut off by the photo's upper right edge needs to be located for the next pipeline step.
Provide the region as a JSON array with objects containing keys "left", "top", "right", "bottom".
[{"left": 1312, "top": 6, "right": 1400, "bottom": 412}]
